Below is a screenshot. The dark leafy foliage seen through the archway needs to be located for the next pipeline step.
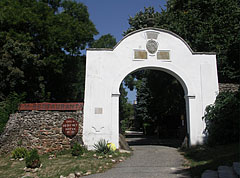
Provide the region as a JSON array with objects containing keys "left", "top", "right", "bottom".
[{"left": 136, "top": 70, "right": 185, "bottom": 134}]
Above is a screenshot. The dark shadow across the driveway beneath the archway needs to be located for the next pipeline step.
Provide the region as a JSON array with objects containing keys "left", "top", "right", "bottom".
[{"left": 125, "top": 132, "right": 182, "bottom": 148}]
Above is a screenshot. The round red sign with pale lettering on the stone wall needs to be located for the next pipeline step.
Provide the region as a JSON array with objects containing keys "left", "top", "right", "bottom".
[{"left": 62, "top": 118, "right": 78, "bottom": 138}]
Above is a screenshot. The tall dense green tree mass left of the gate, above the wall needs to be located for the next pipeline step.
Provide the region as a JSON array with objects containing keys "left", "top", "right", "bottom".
[{"left": 0, "top": 0, "right": 97, "bottom": 102}]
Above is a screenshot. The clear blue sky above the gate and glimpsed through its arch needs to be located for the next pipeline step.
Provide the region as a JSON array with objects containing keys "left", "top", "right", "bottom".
[{"left": 77, "top": 0, "right": 166, "bottom": 103}]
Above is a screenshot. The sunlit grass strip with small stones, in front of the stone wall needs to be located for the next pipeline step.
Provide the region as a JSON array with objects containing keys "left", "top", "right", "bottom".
[{"left": 0, "top": 150, "right": 130, "bottom": 178}]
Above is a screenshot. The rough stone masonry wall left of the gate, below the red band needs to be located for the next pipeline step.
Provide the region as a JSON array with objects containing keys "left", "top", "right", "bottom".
[{"left": 0, "top": 111, "right": 83, "bottom": 154}]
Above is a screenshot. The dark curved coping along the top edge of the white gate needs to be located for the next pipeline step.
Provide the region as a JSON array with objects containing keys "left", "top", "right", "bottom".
[{"left": 87, "top": 27, "right": 216, "bottom": 55}]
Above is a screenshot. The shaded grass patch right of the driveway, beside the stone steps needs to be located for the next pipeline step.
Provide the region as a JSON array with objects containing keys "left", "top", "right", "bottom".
[{"left": 180, "top": 143, "right": 240, "bottom": 178}]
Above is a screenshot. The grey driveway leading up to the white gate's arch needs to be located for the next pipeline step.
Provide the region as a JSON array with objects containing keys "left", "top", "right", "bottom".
[{"left": 86, "top": 134, "right": 190, "bottom": 178}]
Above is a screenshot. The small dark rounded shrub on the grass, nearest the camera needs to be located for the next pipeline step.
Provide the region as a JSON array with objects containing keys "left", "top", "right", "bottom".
[{"left": 25, "top": 149, "right": 41, "bottom": 168}]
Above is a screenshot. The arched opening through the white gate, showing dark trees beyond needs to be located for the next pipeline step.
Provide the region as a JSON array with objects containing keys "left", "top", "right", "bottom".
[{"left": 119, "top": 67, "right": 189, "bottom": 147}]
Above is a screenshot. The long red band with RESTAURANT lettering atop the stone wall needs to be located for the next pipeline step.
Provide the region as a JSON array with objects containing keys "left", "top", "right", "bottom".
[{"left": 18, "top": 103, "right": 83, "bottom": 111}]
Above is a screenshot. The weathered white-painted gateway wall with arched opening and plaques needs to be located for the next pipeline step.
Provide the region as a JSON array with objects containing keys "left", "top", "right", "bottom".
[{"left": 83, "top": 28, "right": 218, "bottom": 149}]
